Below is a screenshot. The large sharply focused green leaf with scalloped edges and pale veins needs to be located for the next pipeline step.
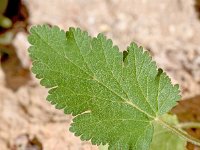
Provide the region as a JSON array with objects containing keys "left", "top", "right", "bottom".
[{"left": 29, "top": 26, "right": 180, "bottom": 150}]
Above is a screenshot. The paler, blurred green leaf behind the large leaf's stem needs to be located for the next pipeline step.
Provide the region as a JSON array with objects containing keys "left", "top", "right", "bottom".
[{"left": 150, "top": 114, "right": 187, "bottom": 150}]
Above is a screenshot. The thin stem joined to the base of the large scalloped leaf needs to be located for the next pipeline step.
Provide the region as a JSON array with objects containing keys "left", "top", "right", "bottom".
[{"left": 156, "top": 119, "right": 200, "bottom": 146}]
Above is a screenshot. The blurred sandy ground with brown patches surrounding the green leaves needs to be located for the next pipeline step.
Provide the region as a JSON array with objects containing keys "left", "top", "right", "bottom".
[{"left": 0, "top": 0, "right": 200, "bottom": 150}]
